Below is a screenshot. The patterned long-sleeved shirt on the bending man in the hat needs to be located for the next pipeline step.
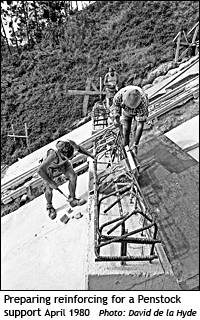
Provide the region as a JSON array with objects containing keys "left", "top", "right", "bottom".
[{"left": 111, "top": 86, "right": 149, "bottom": 121}]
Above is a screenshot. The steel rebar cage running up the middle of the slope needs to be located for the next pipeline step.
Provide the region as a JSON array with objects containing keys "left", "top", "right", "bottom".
[{"left": 94, "top": 127, "right": 160, "bottom": 264}]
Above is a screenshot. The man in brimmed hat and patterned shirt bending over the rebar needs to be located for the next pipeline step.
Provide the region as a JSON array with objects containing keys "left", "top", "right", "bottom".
[{"left": 111, "top": 85, "right": 149, "bottom": 154}]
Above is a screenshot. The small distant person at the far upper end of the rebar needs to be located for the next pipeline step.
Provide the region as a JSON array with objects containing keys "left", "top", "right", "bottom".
[{"left": 103, "top": 67, "right": 119, "bottom": 109}]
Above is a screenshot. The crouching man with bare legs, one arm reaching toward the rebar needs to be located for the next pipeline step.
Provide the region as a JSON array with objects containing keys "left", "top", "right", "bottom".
[{"left": 38, "top": 140, "right": 94, "bottom": 219}]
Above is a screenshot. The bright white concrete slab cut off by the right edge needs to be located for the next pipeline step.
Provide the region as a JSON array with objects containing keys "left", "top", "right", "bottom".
[{"left": 165, "top": 116, "right": 199, "bottom": 162}]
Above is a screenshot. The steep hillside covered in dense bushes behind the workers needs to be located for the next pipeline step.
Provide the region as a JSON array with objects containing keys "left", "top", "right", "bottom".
[{"left": 1, "top": 1, "right": 199, "bottom": 164}]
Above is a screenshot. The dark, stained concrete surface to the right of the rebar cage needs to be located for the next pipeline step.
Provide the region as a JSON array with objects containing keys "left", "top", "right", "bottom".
[{"left": 138, "top": 135, "right": 199, "bottom": 290}]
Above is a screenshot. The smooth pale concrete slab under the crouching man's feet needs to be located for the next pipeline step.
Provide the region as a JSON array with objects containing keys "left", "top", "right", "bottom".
[{"left": 1, "top": 173, "right": 88, "bottom": 290}]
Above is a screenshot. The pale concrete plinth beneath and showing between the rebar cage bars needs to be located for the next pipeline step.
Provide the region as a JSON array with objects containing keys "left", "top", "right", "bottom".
[{"left": 86, "top": 130, "right": 179, "bottom": 290}]
